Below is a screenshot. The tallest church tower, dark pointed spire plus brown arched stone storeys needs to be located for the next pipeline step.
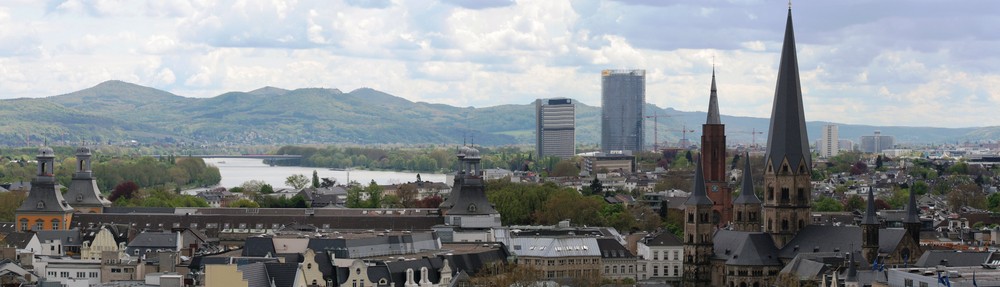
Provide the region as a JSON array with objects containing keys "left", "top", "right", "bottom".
[{"left": 763, "top": 8, "right": 812, "bottom": 248}]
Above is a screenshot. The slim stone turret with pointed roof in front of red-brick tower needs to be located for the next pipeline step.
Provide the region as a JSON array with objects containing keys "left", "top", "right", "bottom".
[{"left": 684, "top": 158, "right": 715, "bottom": 287}]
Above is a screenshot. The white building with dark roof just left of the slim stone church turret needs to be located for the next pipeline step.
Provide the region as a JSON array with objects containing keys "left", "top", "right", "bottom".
[{"left": 636, "top": 232, "right": 684, "bottom": 283}]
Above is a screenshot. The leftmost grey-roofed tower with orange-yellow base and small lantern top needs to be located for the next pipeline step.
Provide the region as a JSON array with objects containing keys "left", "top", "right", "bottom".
[{"left": 15, "top": 147, "right": 73, "bottom": 232}]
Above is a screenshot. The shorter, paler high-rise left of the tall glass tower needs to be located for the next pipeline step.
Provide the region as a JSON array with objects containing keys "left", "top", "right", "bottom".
[{"left": 535, "top": 98, "right": 576, "bottom": 158}]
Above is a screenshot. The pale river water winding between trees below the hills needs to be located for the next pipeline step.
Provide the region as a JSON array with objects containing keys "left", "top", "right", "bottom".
[{"left": 205, "top": 158, "right": 445, "bottom": 189}]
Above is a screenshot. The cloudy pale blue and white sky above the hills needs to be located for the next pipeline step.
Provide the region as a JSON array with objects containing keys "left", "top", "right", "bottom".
[{"left": 0, "top": 0, "right": 1000, "bottom": 127}]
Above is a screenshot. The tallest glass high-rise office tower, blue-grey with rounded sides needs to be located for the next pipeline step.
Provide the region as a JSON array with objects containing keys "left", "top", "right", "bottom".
[{"left": 601, "top": 70, "right": 646, "bottom": 153}]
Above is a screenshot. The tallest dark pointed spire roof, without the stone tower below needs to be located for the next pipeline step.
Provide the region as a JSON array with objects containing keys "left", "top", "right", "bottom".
[{"left": 767, "top": 8, "right": 812, "bottom": 170}]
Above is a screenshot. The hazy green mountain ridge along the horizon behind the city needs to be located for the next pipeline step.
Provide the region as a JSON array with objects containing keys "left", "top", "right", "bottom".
[{"left": 0, "top": 81, "right": 1000, "bottom": 146}]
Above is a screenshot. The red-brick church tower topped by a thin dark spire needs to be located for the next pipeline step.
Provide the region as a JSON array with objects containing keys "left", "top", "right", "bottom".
[{"left": 701, "top": 68, "right": 733, "bottom": 227}]
